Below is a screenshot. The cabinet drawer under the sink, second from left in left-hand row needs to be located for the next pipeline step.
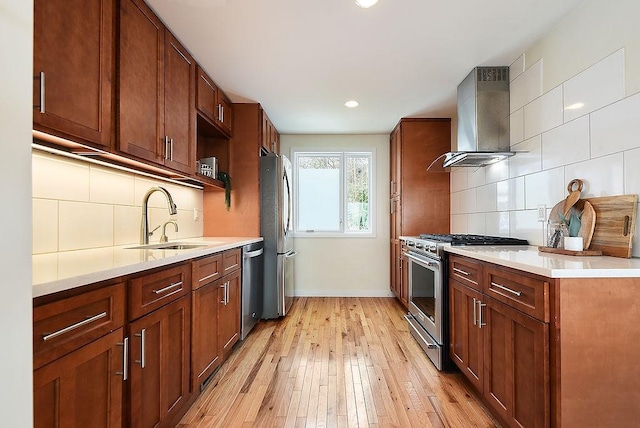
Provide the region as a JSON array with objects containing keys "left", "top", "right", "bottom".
[{"left": 129, "top": 263, "right": 191, "bottom": 320}]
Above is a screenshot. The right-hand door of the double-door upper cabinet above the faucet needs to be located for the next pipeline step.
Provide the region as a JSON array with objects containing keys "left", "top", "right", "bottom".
[{"left": 164, "top": 31, "right": 196, "bottom": 174}]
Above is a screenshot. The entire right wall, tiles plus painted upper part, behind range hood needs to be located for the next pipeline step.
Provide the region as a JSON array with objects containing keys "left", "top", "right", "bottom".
[{"left": 451, "top": 0, "right": 640, "bottom": 257}]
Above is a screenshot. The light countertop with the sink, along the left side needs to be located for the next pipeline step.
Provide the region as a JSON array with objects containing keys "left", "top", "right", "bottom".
[{"left": 32, "top": 237, "right": 262, "bottom": 298}]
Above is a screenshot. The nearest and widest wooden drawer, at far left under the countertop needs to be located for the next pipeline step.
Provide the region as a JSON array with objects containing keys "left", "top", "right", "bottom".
[{"left": 33, "top": 283, "right": 125, "bottom": 368}]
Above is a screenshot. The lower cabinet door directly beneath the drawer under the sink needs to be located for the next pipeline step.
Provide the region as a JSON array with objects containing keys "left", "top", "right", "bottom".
[{"left": 129, "top": 297, "right": 191, "bottom": 428}]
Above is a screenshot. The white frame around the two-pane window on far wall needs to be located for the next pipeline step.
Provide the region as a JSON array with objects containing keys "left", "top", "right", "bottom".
[{"left": 291, "top": 147, "right": 377, "bottom": 238}]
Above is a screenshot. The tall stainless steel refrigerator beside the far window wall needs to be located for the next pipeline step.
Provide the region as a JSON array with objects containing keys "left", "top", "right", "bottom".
[{"left": 260, "top": 153, "right": 296, "bottom": 319}]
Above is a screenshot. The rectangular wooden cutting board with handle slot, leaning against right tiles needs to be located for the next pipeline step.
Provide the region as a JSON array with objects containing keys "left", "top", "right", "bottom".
[{"left": 586, "top": 195, "right": 638, "bottom": 258}]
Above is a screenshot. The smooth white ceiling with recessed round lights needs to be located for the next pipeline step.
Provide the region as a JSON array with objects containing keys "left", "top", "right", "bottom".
[{"left": 147, "top": 0, "right": 582, "bottom": 134}]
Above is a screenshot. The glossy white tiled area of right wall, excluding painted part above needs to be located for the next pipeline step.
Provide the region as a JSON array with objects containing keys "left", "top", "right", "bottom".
[{"left": 451, "top": 49, "right": 640, "bottom": 257}]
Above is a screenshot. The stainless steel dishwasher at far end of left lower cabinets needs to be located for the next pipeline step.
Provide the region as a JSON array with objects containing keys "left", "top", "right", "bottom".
[{"left": 240, "top": 241, "right": 264, "bottom": 340}]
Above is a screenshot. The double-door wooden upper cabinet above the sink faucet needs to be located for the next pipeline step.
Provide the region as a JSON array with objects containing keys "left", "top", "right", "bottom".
[{"left": 118, "top": 0, "right": 195, "bottom": 175}]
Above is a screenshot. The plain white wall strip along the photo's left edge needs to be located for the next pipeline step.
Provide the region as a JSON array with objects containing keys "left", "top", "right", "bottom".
[{"left": 0, "top": 0, "right": 33, "bottom": 427}]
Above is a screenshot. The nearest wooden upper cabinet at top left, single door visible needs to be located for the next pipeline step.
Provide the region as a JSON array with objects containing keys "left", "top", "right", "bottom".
[{"left": 33, "top": 0, "right": 115, "bottom": 148}]
